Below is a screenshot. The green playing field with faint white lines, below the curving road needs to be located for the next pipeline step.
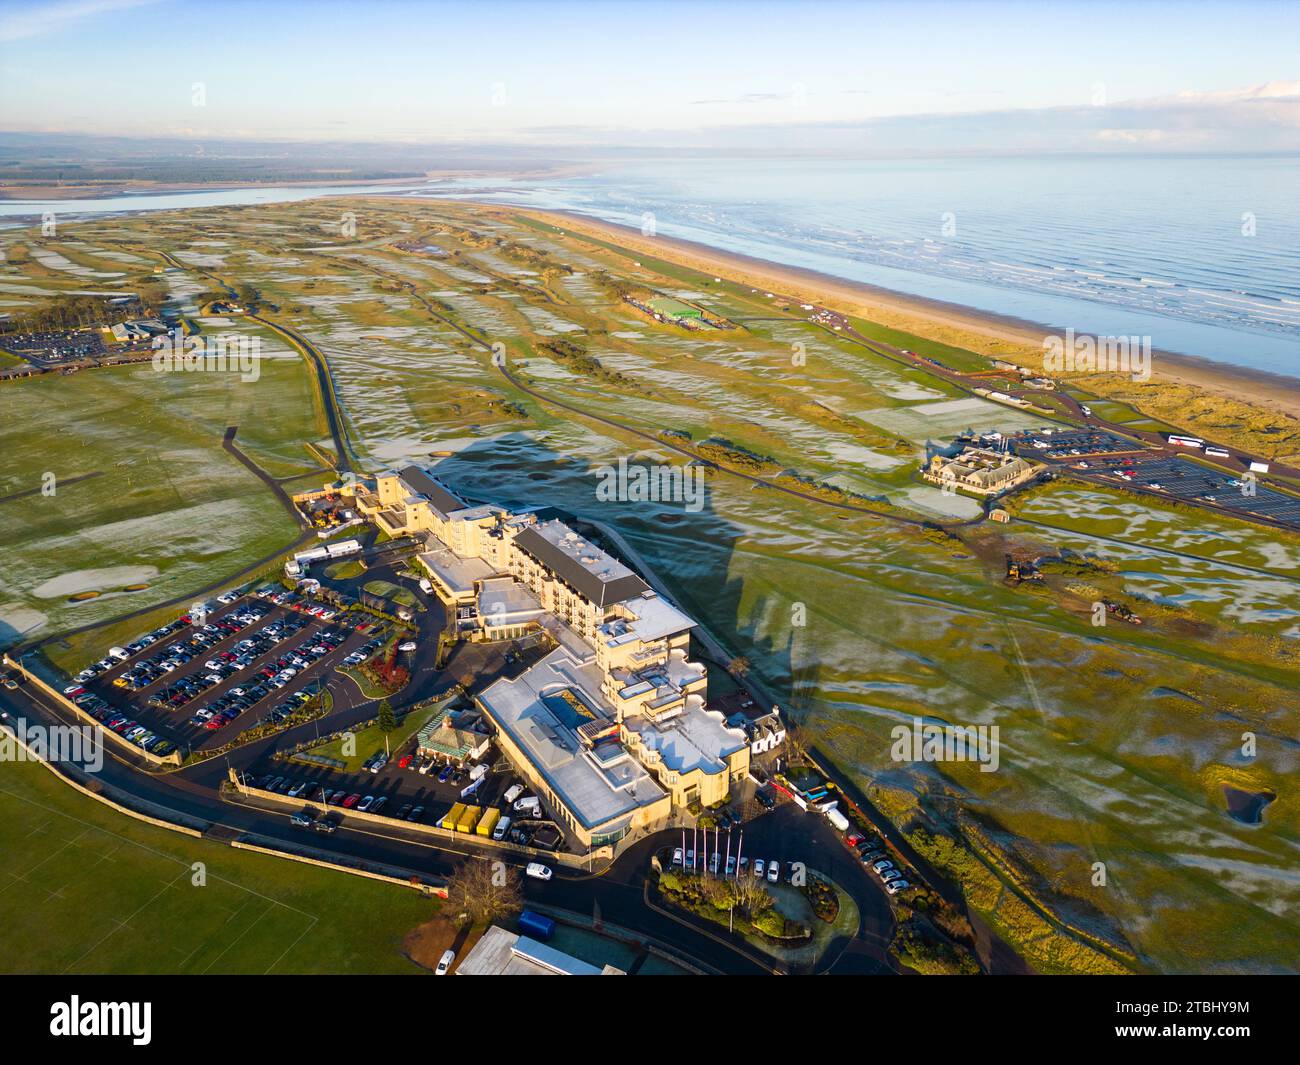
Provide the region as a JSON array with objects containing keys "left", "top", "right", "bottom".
[{"left": 0, "top": 762, "right": 433, "bottom": 974}]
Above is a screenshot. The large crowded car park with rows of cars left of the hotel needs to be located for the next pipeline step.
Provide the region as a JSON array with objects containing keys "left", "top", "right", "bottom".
[{"left": 68, "top": 589, "right": 382, "bottom": 754}]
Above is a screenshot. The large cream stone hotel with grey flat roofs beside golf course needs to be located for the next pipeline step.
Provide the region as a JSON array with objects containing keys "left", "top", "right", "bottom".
[{"left": 340, "top": 466, "right": 781, "bottom": 849}]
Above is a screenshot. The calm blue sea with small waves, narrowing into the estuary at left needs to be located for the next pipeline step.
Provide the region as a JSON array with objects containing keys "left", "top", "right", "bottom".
[{"left": 0, "top": 155, "right": 1300, "bottom": 378}]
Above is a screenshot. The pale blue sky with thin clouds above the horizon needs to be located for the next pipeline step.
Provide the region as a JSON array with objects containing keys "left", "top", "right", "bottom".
[{"left": 0, "top": 0, "right": 1300, "bottom": 152}]
